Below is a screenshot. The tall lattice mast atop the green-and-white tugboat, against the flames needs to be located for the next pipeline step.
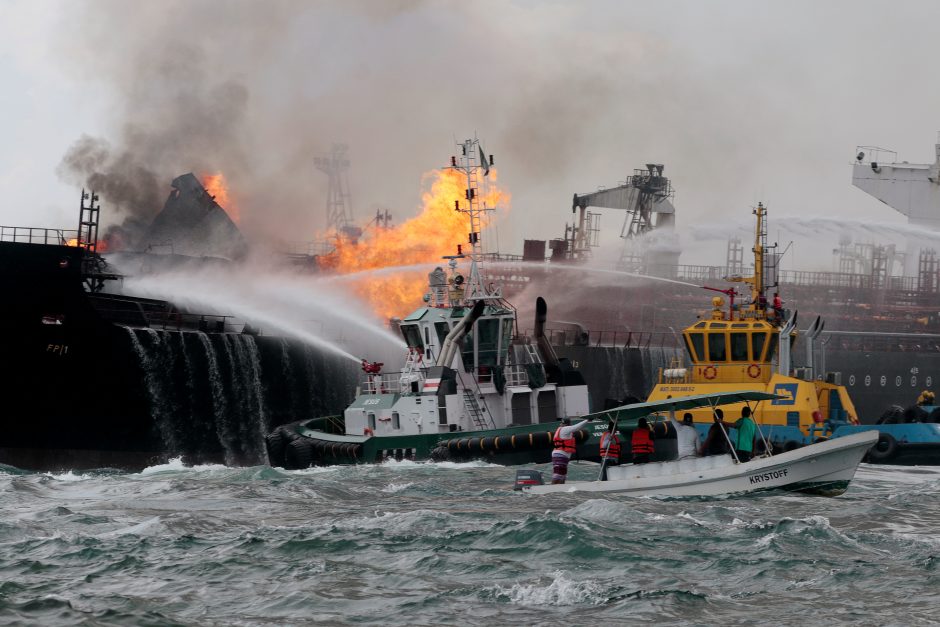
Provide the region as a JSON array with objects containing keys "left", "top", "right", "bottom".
[{"left": 445, "top": 138, "right": 502, "bottom": 301}]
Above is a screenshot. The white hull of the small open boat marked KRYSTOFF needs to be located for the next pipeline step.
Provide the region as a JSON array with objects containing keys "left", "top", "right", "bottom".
[{"left": 523, "top": 431, "right": 878, "bottom": 496}]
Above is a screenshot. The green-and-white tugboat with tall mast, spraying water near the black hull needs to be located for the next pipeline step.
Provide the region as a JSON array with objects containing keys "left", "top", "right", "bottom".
[{"left": 266, "top": 139, "right": 605, "bottom": 468}]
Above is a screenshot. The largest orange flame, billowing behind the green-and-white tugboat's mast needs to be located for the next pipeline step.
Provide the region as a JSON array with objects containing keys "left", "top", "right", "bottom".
[{"left": 321, "top": 168, "right": 510, "bottom": 319}]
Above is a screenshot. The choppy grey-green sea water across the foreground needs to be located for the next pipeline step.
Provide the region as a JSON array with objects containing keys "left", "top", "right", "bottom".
[{"left": 0, "top": 462, "right": 940, "bottom": 625}]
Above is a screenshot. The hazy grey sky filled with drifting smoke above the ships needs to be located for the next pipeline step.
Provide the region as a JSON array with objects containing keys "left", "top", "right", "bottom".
[{"left": 0, "top": 0, "right": 940, "bottom": 263}]
